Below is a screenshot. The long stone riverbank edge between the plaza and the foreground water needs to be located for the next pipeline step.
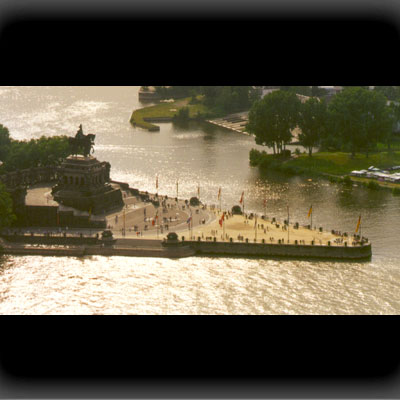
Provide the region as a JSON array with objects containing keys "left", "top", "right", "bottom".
[{"left": 0, "top": 231, "right": 372, "bottom": 261}]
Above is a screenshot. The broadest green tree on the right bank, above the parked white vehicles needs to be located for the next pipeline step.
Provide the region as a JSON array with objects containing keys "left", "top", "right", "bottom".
[{"left": 328, "top": 87, "right": 391, "bottom": 157}]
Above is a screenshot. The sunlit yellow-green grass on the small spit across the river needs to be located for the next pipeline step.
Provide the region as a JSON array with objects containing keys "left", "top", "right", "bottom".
[{"left": 130, "top": 97, "right": 212, "bottom": 129}]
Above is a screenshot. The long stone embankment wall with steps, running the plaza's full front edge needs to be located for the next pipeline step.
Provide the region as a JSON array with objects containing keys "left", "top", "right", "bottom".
[{"left": 0, "top": 235, "right": 371, "bottom": 261}]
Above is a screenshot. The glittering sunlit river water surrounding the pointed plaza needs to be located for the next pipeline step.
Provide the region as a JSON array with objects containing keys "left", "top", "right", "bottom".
[{"left": 0, "top": 86, "right": 400, "bottom": 314}]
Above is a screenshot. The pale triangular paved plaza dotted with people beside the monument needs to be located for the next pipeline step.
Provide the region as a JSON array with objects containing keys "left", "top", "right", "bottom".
[{"left": 24, "top": 185, "right": 354, "bottom": 246}]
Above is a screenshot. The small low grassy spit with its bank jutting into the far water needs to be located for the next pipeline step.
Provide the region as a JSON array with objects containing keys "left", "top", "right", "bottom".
[{"left": 130, "top": 97, "right": 210, "bottom": 132}]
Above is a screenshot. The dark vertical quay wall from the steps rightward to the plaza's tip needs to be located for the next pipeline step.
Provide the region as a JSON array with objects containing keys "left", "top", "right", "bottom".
[{"left": 186, "top": 241, "right": 371, "bottom": 260}]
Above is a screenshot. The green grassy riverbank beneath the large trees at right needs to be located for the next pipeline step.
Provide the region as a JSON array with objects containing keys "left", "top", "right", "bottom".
[{"left": 250, "top": 149, "right": 400, "bottom": 190}]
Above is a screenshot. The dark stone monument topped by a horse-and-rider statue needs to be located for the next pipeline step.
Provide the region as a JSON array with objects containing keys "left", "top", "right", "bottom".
[{"left": 52, "top": 125, "right": 124, "bottom": 214}]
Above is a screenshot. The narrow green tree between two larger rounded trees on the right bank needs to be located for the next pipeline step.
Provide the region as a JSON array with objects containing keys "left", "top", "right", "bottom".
[{"left": 298, "top": 97, "right": 327, "bottom": 157}]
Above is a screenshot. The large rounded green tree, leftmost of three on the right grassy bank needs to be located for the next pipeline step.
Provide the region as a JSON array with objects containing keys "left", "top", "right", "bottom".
[{"left": 247, "top": 90, "right": 301, "bottom": 154}]
